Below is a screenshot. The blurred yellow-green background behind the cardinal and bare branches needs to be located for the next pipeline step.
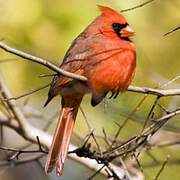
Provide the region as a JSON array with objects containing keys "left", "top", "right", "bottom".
[{"left": 0, "top": 0, "right": 180, "bottom": 180}]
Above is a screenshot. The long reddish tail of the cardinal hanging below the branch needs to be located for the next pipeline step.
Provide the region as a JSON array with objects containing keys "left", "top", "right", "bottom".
[{"left": 45, "top": 97, "right": 82, "bottom": 176}]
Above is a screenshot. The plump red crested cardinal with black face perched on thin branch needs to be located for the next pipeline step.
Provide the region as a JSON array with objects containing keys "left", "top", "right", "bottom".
[{"left": 45, "top": 6, "right": 136, "bottom": 175}]
